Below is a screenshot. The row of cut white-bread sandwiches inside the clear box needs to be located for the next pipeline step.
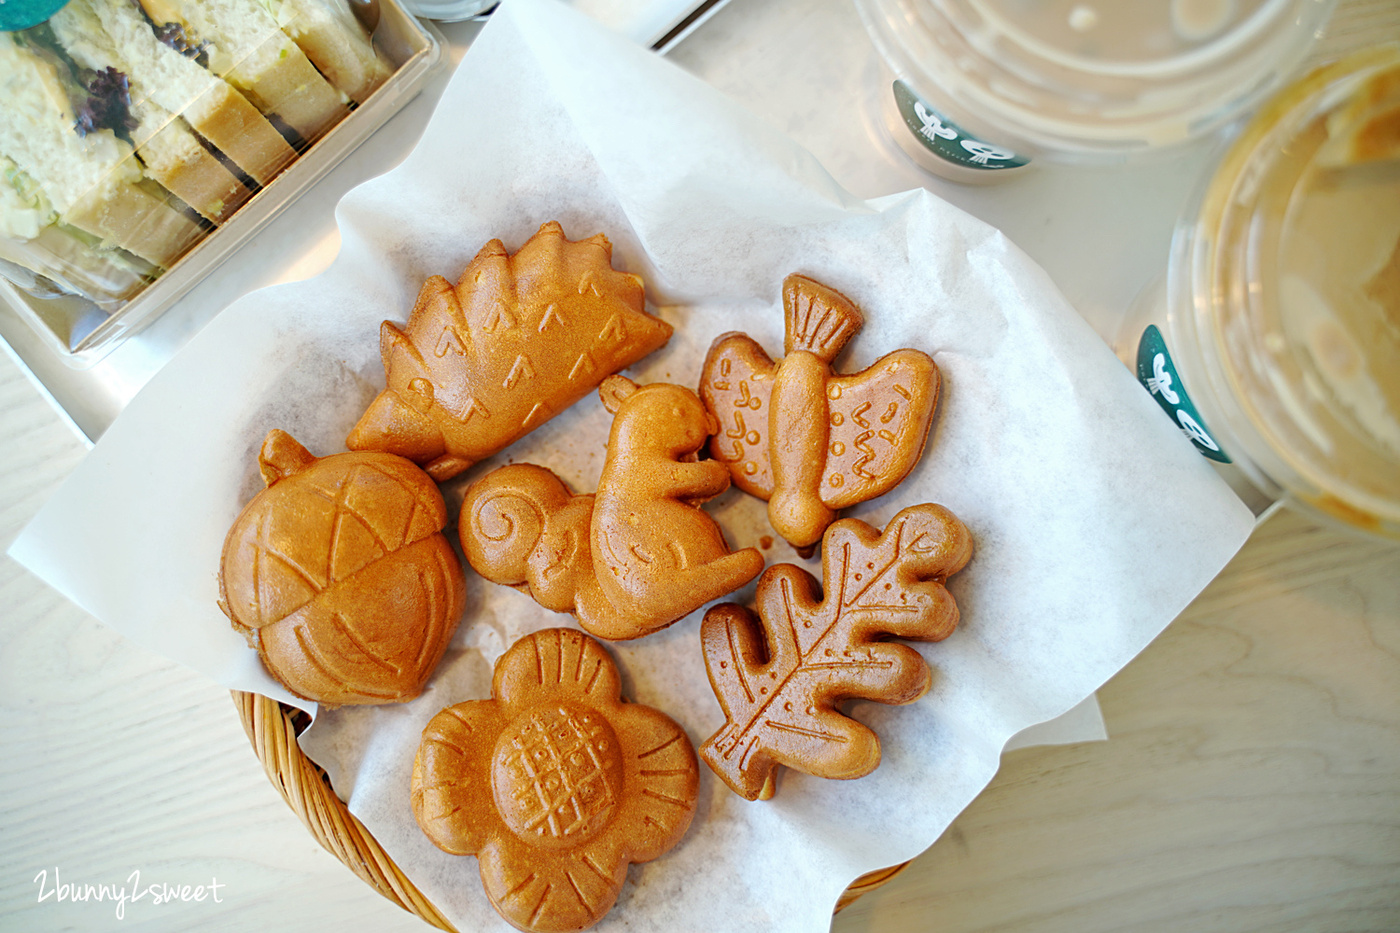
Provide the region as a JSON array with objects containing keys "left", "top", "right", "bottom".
[{"left": 0, "top": 0, "right": 392, "bottom": 323}]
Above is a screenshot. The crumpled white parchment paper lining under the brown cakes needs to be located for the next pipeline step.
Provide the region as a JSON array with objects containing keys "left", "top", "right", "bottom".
[{"left": 11, "top": 0, "right": 1253, "bottom": 932}]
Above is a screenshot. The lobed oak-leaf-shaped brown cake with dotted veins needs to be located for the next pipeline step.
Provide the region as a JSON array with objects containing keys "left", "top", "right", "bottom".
[{"left": 700, "top": 504, "right": 972, "bottom": 800}]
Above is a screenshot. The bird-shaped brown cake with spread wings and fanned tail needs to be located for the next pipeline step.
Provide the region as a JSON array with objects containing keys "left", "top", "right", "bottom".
[{"left": 700, "top": 275, "right": 939, "bottom": 552}]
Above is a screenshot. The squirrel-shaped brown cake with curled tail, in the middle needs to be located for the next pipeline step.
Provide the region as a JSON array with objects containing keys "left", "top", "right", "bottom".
[{"left": 458, "top": 375, "right": 763, "bottom": 640}]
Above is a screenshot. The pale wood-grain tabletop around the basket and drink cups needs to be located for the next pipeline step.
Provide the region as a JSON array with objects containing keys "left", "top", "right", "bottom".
[{"left": 0, "top": 0, "right": 1400, "bottom": 933}]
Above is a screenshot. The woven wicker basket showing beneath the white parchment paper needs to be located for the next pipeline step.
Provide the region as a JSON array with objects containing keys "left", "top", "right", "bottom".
[{"left": 232, "top": 691, "right": 909, "bottom": 933}]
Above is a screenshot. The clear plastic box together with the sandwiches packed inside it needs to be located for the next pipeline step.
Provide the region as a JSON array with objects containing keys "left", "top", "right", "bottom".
[{"left": 0, "top": 0, "right": 441, "bottom": 367}]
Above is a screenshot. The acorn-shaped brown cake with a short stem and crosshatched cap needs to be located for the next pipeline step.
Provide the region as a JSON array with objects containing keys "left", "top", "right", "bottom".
[{"left": 218, "top": 430, "right": 466, "bottom": 706}]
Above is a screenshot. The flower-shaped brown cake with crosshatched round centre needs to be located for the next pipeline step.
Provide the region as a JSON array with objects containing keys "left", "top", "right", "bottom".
[{"left": 413, "top": 629, "right": 699, "bottom": 930}]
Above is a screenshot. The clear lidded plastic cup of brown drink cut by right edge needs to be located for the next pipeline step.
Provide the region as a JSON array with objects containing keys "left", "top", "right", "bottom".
[{"left": 1117, "top": 45, "right": 1400, "bottom": 538}]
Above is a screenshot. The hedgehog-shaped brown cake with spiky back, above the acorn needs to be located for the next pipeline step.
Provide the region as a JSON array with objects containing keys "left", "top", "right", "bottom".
[{"left": 346, "top": 221, "right": 672, "bottom": 481}]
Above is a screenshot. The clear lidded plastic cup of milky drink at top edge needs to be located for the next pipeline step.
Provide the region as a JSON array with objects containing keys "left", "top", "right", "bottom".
[{"left": 857, "top": 0, "right": 1334, "bottom": 181}]
